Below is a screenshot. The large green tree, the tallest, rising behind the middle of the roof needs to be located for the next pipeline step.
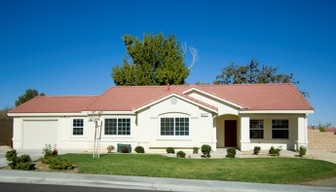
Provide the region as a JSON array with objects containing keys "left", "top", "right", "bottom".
[{"left": 112, "top": 33, "right": 190, "bottom": 85}]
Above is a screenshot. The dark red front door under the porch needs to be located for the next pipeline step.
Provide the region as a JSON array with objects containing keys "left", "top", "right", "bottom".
[{"left": 224, "top": 120, "right": 237, "bottom": 147}]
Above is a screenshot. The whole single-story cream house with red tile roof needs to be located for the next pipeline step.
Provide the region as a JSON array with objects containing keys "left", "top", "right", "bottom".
[{"left": 9, "top": 83, "right": 314, "bottom": 152}]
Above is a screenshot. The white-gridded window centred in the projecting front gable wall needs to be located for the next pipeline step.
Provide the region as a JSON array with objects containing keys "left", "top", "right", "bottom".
[{"left": 161, "top": 117, "right": 189, "bottom": 136}]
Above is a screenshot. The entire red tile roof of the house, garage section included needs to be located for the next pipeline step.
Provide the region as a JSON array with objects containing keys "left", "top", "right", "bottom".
[{"left": 10, "top": 83, "right": 313, "bottom": 113}]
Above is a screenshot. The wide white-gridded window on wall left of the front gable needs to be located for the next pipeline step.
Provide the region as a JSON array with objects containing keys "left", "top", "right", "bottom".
[{"left": 105, "top": 118, "right": 131, "bottom": 135}]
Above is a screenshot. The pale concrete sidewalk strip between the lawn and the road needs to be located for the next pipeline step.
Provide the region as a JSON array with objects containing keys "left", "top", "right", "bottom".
[{"left": 0, "top": 170, "right": 336, "bottom": 192}]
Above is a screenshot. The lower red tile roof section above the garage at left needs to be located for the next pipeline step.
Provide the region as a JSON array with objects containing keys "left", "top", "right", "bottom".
[{"left": 9, "top": 96, "right": 98, "bottom": 113}]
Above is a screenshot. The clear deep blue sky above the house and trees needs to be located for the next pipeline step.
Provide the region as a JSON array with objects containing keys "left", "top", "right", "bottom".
[{"left": 0, "top": 0, "right": 336, "bottom": 126}]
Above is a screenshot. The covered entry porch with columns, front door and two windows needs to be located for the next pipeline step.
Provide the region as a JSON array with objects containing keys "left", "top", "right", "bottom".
[{"left": 215, "top": 114, "right": 308, "bottom": 151}]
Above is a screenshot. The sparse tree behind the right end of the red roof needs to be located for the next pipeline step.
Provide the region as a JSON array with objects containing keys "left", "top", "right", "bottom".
[{"left": 214, "top": 59, "right": 308, "bottom": 97}]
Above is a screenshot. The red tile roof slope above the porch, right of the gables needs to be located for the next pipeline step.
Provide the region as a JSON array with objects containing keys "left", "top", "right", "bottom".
[{"left": 196, "top": 83, "right": 313, "bottom": 110}]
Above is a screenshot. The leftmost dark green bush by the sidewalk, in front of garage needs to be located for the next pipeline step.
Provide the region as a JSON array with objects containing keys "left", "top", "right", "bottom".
[{"left": 6, "top": 149, "right": 35, "bottom": 170}]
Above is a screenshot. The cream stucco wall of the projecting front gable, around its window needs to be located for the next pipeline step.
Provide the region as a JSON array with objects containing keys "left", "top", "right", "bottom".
[{"left": 137, "top": 97, "right": 216, "bottom": 152}]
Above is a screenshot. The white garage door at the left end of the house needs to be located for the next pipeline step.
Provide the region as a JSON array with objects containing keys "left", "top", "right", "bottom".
[{"left": 22, "top": 120, "right": 57, "bottom": 150}]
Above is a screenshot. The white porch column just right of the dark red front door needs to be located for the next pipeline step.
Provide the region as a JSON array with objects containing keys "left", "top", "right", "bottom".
[{"left": 240, "top": 117, "right": 251, "bottom": 151}]
